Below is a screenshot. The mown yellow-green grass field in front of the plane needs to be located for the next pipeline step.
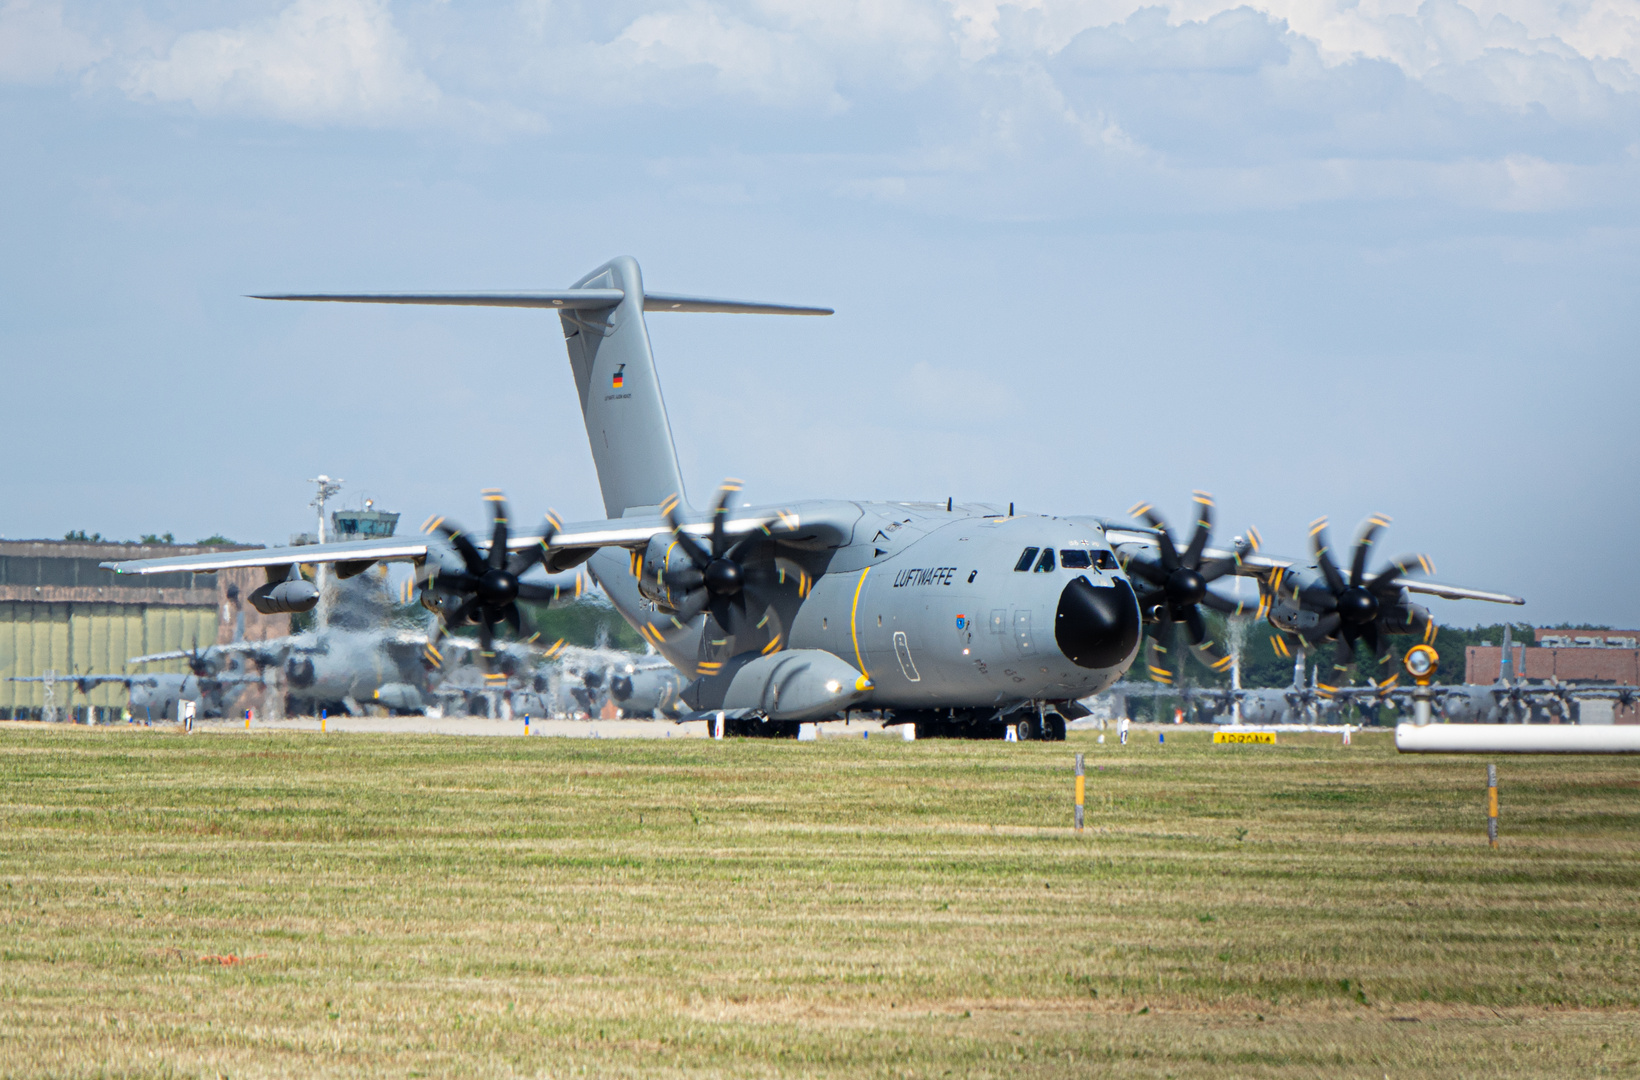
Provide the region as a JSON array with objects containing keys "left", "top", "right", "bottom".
[{"left": 0, "top": 724, "right": 1640, "bottom": 1080}]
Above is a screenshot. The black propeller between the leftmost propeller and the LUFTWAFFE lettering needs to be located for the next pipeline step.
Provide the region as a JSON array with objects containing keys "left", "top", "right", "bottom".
[{"left": 661, "top": 480, "right": 812, "bottom": 656}]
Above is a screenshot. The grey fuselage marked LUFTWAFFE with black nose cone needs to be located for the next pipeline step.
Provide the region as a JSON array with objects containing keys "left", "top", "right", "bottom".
[{"left": 590, "top": 503, "right": 1140, "bottom": 710}]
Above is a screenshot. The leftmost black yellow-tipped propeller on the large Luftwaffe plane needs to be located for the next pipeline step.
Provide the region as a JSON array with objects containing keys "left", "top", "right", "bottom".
[{"left": 417, "top": 488, "right": 581, "bottom": 678}]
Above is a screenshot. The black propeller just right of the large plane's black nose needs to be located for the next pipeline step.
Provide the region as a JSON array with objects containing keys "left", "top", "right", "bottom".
[{"left": 1125, "top": 492, "right": 1260, "bottom": 685}]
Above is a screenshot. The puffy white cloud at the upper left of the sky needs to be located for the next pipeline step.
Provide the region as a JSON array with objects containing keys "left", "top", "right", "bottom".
[{"left": 123, "top": 0, "right": 440, "bottom": 123}]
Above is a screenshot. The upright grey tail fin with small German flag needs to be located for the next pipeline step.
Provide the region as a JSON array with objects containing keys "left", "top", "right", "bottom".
[{"left": 559, "top": 256, "right": 684, "bottom": 518}]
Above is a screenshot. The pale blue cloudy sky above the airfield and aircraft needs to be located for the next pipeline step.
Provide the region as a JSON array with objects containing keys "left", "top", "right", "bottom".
[{"left": 0, "top": 0, "right": 1640, "bottom": 628}]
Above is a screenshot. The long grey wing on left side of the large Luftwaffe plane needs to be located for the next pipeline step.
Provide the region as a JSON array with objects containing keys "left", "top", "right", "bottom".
[{"left": 102, "top": 503, "right": 858, "bottom": 574}]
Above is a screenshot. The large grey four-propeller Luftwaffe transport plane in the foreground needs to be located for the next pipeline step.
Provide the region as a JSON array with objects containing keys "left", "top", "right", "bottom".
[{"left": 110, "top": 257, "right": 1512, "bottom": 737}]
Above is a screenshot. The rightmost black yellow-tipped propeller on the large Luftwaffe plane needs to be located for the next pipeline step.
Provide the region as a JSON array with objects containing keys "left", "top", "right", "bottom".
[{"left": 1301, "top": 515, "right": 1435, "bottom": 693}]
